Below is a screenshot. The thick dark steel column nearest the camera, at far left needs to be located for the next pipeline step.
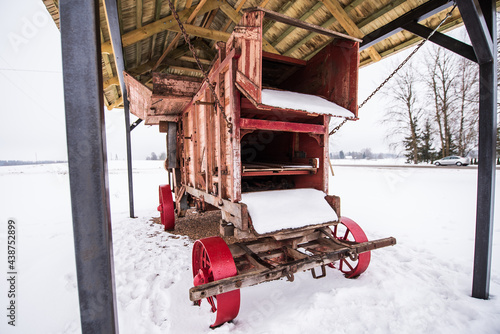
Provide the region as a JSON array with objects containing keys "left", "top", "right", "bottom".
[{"left": 60, "top": 0, "right": 118, "bottom": 333}]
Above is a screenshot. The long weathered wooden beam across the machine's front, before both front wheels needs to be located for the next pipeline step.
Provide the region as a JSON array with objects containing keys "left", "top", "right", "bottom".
[{"left": 189, "top": 238, "right": 396, "bottom": 301}]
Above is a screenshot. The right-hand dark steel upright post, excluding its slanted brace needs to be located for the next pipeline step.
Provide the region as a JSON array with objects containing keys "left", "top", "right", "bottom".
[{"left": 472, "top": 0, "right": 497, "bottom": 299}]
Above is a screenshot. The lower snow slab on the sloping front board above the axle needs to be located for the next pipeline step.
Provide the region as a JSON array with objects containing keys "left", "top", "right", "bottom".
[{"left": 241, "top": 189, "right": 338, "bottom": 234}]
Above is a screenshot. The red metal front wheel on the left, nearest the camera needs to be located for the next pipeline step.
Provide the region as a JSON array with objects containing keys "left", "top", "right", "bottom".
[{"left": 193, "top": 237, "right": 240, "bottom": 328}]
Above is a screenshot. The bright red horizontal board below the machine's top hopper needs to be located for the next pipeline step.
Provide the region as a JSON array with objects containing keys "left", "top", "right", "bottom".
[{"left": 240, "top": 118, "right": 325, "bottom": 134}]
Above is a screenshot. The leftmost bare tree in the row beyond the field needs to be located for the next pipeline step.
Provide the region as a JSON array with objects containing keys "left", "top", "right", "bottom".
[{"left": 383, "top": 63, "right": 422, "bottom": 163}]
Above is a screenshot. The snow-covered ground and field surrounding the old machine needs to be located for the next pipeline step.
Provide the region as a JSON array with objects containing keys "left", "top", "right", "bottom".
[{"left": 0, "top": 161, "right": 500, "bottom": 334}]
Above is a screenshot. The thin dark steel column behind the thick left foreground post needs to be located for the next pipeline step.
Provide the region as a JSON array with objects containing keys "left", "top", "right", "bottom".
[{"left": 104, "top": 0, "right": 135, "bottom": 218}]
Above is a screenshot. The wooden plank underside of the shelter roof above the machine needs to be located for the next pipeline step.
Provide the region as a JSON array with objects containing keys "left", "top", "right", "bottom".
[{"left": 42, "top": 0, "right": 500, "bottom": 109}]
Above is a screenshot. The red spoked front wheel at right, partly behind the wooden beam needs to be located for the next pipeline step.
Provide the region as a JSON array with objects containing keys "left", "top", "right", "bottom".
[{"left": 332, "top": 217, "right": 371, "bottom": 278}]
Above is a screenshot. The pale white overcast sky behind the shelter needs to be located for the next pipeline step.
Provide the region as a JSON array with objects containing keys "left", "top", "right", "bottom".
[{"left": 0, "top": 0, "right": 468, "bottom": 160}]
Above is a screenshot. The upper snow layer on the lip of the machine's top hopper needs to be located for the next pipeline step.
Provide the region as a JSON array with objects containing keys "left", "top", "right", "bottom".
[{"left": 262, "top": 89, "right": 354, "bottom": 118}]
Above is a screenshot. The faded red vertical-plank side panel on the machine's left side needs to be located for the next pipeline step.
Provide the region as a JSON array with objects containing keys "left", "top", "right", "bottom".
[{"left": 181, "top": 46, "right": 241, "bottom": 202}]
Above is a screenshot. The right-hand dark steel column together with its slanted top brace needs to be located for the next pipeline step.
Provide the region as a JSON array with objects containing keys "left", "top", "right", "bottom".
[{"left": 457, "top": 0, "right": 497, "bottom": 299}]
